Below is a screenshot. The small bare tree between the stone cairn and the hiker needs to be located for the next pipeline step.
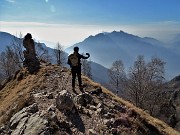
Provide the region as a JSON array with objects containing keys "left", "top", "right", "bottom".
[{"left": 54, "top": 42, "right": 65, "bottom": 66}]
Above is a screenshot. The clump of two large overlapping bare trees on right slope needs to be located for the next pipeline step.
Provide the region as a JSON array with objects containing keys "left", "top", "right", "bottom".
[{"left": 126, "top": 56, "right": 165, "bottom": 114}]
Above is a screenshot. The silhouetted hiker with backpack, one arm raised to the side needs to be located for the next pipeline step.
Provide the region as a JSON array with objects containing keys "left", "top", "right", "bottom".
[{"left": 68, "top": 47, "right": 90, "bottom": 91}]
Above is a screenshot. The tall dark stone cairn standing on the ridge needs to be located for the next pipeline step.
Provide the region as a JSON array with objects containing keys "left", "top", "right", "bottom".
[{"left": 23, "top": 33, "right": 40, "bottom": 73}]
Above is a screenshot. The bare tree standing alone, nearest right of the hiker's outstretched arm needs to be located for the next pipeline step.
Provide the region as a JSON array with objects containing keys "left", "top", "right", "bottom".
[{"left": 108, "top": 60, "right": 126, "bottom": 93}]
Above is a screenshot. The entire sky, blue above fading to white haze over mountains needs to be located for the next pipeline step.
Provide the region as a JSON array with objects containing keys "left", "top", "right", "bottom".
[{"left": 0, "top": 0, "right": 180, "bottom": 48}]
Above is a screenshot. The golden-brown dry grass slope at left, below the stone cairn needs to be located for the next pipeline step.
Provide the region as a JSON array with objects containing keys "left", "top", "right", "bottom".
[{"left": 0, "top": 69, "right": 44, "bottom": 125}]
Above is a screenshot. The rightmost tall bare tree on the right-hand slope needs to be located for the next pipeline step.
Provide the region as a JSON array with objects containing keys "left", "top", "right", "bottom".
[{"left": 145, "top": 57, "right": 165, "bottom": 114}]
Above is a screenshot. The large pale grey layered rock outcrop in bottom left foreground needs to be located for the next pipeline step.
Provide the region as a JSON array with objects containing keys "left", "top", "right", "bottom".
[{"left": 9, "top": 103, "right": 48, "bottom": 135}]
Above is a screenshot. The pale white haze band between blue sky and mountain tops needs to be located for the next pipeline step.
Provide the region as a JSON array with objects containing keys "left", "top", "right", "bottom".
[{"left": 0, "top": 21, "right": 180, "bottom": 46}]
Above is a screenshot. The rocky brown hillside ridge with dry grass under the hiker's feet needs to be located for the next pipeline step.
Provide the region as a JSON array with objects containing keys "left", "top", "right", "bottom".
[{"left": 0, "top": 64, "right": 179, "bottom": 135}]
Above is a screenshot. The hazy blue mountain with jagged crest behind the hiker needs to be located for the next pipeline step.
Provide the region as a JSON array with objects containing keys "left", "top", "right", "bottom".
[{"left": 66, "top": 31, "right": 180, "bottom": 78}]
